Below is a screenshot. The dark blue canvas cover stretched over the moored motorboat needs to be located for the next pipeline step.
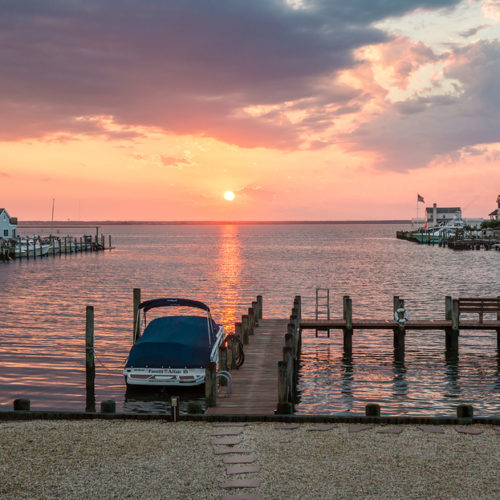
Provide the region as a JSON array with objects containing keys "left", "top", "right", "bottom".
[{"left": 125, "top": 316, "right": 218, "bottom": 368}]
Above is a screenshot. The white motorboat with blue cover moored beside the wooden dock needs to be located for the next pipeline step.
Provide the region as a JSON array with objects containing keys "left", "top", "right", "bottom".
[{"left": 123, "top": 298, "right": 225, "bottom": 387}]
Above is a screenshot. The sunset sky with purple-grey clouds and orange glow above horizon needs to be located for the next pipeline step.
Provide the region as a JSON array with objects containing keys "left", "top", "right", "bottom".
[{"left": 0, "top": 0, "right": 500, "bottom": 221}]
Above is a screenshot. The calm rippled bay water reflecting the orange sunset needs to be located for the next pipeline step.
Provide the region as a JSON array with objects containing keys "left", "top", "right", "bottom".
[{"left": 0, "top": 224, "right": 500, "bottom": 416}]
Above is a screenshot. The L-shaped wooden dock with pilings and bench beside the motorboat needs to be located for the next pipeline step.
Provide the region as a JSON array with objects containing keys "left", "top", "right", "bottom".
[{"left": 201, "top": 295, "right": 500, "bottom": 416}]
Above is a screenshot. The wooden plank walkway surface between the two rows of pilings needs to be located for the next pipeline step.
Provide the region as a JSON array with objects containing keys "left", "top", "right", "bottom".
[{"left": 206, "top": 319, "right": 288, "bottom": 415}]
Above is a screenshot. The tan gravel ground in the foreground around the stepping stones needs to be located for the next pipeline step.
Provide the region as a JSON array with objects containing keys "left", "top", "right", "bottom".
[{"left": 0, "top": 420, "right": 500, "bottom": 499}]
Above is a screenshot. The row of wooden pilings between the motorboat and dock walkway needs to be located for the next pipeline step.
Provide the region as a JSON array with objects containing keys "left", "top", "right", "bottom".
[{"left": 205, "top": 295, "right": 262, "bottom": 408}]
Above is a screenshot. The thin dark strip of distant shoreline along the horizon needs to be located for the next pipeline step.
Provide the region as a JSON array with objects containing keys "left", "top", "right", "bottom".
[{"left": 19, "top": 219, "right": 411, "bottom": 229}]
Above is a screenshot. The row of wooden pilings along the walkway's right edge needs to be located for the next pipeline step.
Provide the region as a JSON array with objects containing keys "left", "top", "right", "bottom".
[{"left": 276, "top": 295, "right": 302, "bottom": 415}]
